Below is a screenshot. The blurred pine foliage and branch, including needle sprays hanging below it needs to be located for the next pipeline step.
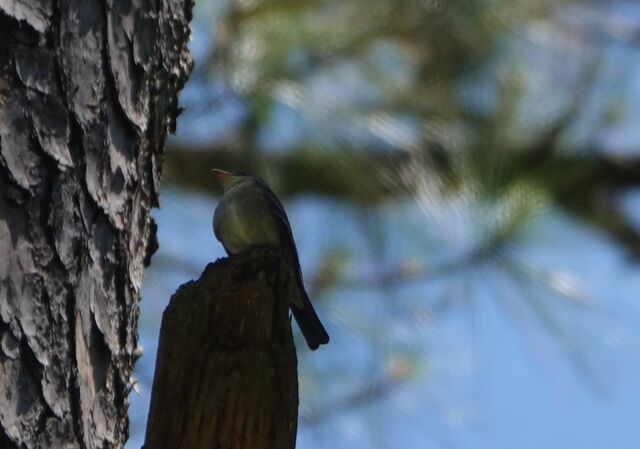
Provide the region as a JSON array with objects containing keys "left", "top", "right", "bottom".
[{"left": 158, "top": 0, "right": 640, "bottom": 438}]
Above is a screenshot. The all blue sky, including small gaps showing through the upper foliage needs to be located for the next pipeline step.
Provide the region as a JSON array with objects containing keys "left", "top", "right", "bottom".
[{"left": 127, "top": 2, "right": 640, "bottom": 449}]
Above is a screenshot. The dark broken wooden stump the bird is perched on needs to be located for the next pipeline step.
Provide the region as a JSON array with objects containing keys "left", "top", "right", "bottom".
[{"left": 144, "top": 248, "right": 298, "bottom": 449}]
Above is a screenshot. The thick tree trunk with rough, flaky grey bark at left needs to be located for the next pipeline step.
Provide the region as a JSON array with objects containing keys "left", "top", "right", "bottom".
[{"left": 0, "top": 0, "right": 192, "bottom": 449}]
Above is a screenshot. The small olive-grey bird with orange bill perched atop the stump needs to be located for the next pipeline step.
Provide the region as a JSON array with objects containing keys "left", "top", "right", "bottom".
[{"left": 212, "top": 169, "right": 329, "bottom": 350}]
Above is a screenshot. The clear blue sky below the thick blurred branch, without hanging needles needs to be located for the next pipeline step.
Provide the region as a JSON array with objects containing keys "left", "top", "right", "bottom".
[{"left": 128, "top": 189, "right": 640, "bottom": 449}]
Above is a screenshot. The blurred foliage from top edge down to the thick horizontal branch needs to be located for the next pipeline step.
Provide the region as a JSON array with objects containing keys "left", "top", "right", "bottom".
[{"left": 166, "top": 0, "right": 640, "bottom": 257}]
